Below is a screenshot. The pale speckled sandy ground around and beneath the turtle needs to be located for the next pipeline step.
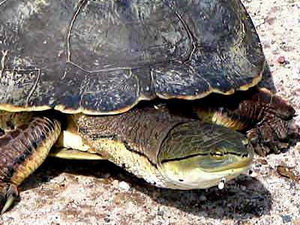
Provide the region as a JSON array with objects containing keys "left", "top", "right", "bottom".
[{"left": 0, "top": 0, "right": 300, "bottom": 225}]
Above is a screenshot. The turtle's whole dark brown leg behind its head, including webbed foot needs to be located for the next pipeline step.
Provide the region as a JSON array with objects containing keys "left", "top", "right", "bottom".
[{"left": 195, "top": 88, "right": 296, "bottom": 156}]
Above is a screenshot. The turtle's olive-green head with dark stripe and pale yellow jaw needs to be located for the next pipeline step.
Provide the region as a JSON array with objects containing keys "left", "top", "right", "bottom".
[{"left": 158, "top": 122, "right": 254, "bottom": 189}]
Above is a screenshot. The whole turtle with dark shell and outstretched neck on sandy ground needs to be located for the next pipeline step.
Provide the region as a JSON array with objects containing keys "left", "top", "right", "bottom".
[{"left": 0, "top": 0, "right": 295, "bottom": 213}]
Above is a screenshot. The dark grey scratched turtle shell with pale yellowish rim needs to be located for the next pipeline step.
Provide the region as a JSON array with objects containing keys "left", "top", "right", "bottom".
[{"left": 0, "top": 0, "right": 265, "bottom": 114}]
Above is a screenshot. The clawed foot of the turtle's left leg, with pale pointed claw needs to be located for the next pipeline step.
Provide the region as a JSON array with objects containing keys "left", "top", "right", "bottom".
[{"left": 0, "top": 183, "right": 19, "bottom": 214}]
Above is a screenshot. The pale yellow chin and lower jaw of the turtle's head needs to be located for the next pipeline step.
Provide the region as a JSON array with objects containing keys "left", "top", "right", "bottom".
[{"left": 159, "top": 156, "right": 253, "bottom": 190}]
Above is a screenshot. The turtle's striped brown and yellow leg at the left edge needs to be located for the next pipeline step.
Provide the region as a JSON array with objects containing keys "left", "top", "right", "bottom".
[{"left": 0, "top": 112, "right": 61, "bottom": 214}]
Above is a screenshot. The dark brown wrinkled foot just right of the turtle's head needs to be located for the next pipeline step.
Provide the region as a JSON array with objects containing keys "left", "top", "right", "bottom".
[{"left": 240, "top": 88, "right": 297, "bottom": 156}]
